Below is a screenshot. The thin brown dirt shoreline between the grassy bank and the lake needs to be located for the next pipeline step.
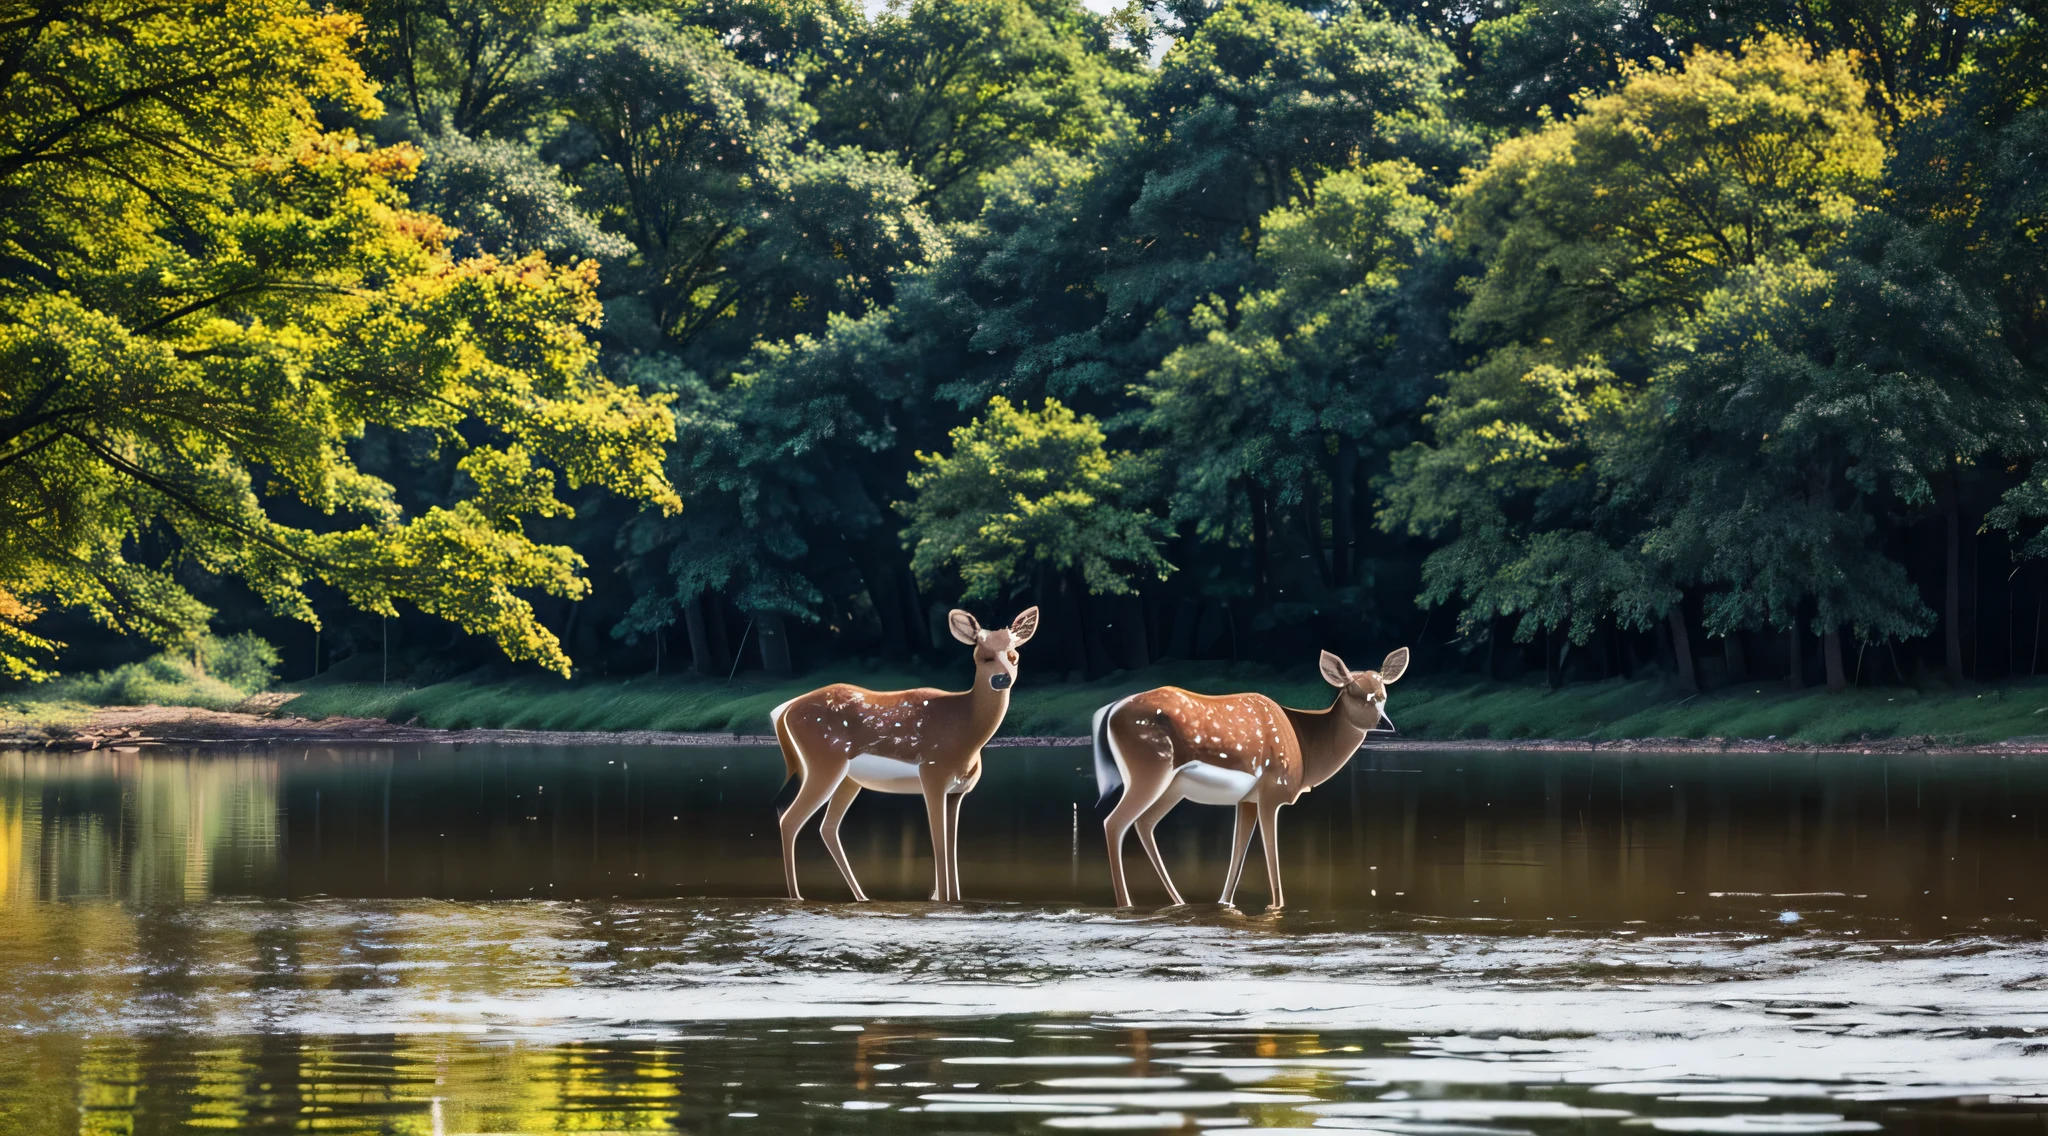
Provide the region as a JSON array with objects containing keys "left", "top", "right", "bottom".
[{"left": 12, "top": 700, "right": 2048, "bottom": 755}]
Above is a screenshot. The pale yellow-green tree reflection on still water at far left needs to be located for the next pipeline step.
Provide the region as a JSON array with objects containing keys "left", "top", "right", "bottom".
[{"left": 0, "top": 753, "right": 279, "bottom": 905}]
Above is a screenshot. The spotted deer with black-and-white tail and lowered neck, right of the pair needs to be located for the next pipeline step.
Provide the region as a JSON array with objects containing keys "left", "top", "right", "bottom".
[{"left": 1094, "top": 647, "right": 1409, "bottom": 911}]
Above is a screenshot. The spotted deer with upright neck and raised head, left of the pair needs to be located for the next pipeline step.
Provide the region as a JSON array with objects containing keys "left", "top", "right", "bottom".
[{"left": 768, "top": 608, "right": 1038, "bottom": 903}]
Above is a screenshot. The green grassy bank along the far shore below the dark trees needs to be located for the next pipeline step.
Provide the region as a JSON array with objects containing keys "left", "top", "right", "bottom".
[{"left": 272, "top": 663, "right": 2048, "bottom": 743}]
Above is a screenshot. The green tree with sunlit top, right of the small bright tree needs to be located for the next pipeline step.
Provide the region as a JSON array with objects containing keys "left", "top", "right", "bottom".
[{"left": 1135, "top": 162, "right": 1444, "bottom": 589}]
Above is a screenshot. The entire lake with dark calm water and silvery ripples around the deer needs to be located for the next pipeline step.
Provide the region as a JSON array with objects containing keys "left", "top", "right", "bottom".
[{"left": 0, "top": 747, "right": 2048, "bottom": 1136}]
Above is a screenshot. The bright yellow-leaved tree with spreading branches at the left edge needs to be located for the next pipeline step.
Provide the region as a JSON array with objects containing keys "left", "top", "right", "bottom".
[{"left": 0, "top": 0, "right": 680, "bottom": 675}]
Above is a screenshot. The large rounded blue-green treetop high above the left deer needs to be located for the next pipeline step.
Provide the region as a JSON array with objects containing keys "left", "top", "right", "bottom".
[{"left": 551, "top": 12, "right": 942, "bottom": 368}]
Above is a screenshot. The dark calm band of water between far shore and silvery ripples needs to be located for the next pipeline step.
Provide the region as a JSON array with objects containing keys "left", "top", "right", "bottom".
[{"left": 0, "top": 747, "right": 2048, "bottom": 933}]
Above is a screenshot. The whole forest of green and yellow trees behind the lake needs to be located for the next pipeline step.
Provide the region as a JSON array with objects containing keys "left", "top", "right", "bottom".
[{"left": 0, "top": 0, "right": 2048, "bottom": 690}]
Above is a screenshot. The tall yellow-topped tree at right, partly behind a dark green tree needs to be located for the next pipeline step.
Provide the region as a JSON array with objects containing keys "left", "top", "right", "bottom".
[{"left": 1382, "top": 37, "right": 1884, "bottom": 684}]
